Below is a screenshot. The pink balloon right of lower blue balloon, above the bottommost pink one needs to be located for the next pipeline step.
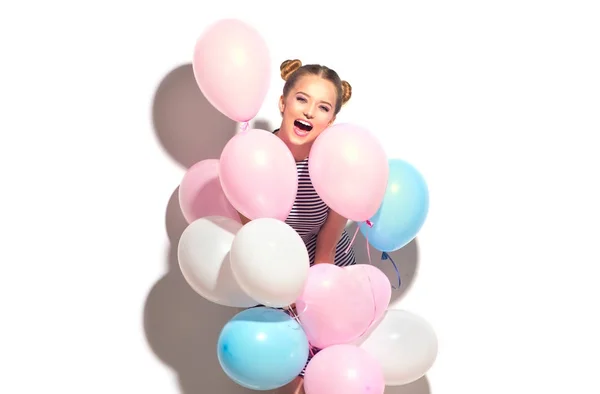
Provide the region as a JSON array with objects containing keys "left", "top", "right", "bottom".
[{"left": 296, "top": 264, "right": 375, "bottom": 349}]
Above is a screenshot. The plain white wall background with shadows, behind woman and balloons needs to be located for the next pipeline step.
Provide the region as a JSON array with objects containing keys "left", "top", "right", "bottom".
[{"left": 0, "top": 0, "right": 600, "bottom": 394}]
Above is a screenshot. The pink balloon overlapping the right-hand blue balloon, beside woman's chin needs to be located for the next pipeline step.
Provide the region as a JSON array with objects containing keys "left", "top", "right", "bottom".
[{"left": 308, "top": 123, "right": 389, "bottom": 222}]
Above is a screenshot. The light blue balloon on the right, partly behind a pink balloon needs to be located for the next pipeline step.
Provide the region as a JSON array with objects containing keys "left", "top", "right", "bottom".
[{"left": 358, "top": 159, "right": 429, "bottom": 252}]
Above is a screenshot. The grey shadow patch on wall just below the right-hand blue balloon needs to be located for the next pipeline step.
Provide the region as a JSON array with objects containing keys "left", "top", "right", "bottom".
[{"left": 346, "top": 223, "right": 419, "bottom": 308}]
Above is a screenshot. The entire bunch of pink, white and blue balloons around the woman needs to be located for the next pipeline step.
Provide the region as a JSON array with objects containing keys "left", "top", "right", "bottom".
[{"left": 177, "top": 19, "right": 438, "bottom": 394}]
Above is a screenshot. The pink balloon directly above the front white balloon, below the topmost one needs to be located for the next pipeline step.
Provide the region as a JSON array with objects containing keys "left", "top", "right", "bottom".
[{"left": 220, "top": 129, "right": 298, "bottom": 221}]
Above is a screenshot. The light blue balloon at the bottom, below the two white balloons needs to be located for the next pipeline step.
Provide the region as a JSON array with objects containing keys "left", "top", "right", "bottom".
[{"left": 217, "top": 307, "right": 309, "bottom": 390}]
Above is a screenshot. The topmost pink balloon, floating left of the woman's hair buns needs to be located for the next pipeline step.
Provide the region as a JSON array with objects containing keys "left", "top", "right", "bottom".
[{"left": 192, "top": 19, "right": 271, "bottom": 122}]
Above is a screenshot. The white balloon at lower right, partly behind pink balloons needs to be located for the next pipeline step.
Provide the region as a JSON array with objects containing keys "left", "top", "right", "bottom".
[{"left": 360, "top": 309, "right": 438, "bottom": 386}]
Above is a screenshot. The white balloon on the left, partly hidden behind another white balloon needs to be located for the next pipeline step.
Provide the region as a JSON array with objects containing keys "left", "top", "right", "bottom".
[{"left": 177, "top": 216, "right": 258, "bottom": 308}]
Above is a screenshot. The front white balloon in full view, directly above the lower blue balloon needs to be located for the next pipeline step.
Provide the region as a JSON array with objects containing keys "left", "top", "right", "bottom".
[{"left": 230, "top": 218, "right": 310, "bottom": 308}]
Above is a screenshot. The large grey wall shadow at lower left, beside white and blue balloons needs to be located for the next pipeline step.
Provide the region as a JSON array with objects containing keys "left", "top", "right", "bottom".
[{"left": 144, "top": 189, "right": 262, "bottom": 394}]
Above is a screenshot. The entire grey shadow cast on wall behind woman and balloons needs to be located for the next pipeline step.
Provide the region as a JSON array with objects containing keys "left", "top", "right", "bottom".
[{"left": 143, "top": 64, "right": 429, "bottom": 394}]
